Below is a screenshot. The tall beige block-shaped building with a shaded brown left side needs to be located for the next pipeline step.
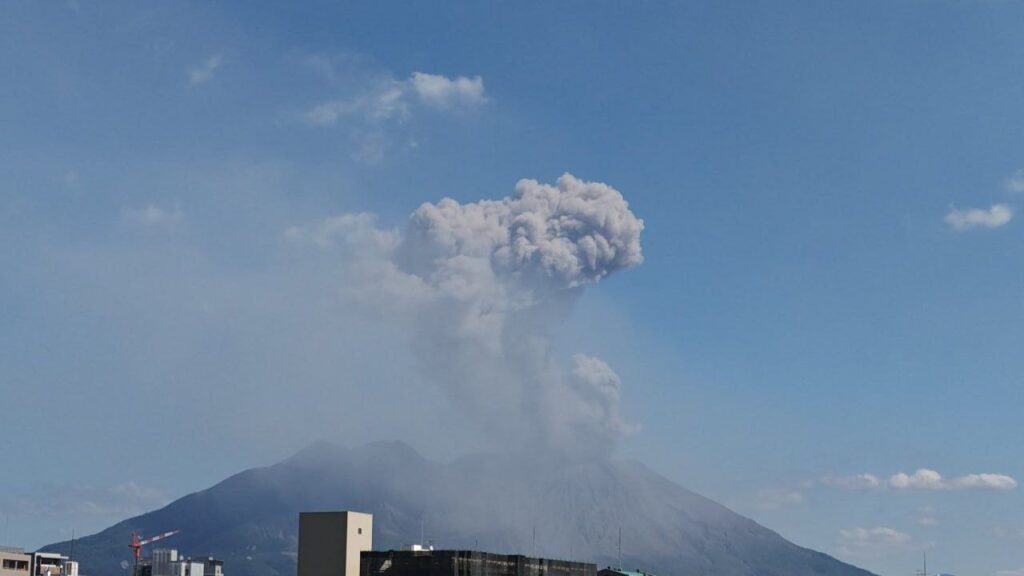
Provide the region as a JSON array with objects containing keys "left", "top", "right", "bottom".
[{"left": 298, "top": 511, "right": 374, "bottom": 576}]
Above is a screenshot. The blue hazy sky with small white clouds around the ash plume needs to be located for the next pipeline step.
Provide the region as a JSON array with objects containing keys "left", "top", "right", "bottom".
[{"left": 6, "top": 0, "right": 1024, "bottom": 576}]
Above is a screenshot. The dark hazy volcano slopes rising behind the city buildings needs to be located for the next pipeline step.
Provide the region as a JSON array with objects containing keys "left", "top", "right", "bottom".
[{"left": 44, "top": 443, "right": 870, "bottom": 576}]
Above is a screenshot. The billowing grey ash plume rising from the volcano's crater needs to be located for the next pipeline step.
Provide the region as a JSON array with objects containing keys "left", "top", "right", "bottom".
[{"left": 288, "top": 174, "right": 643, "bottom": 458}]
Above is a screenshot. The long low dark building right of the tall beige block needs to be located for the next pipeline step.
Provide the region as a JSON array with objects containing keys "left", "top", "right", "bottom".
[{"left": 359, "top": 549, "right": 597, "bottom": 576}]
